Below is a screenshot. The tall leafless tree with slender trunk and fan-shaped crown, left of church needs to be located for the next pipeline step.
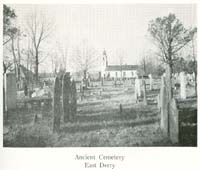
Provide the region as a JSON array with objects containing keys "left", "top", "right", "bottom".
[{"left": 27, "top": 11, "right": 53, "bottom": 83}]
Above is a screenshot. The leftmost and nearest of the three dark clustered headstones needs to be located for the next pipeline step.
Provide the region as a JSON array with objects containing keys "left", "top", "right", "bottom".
[{"left": 53, "top": 77, "right": 61, "bottom": 132}]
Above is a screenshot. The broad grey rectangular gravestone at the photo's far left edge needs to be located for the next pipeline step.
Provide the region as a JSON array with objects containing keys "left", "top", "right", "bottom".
[{"left": 4, "top": 73, "right": 17, "bottom": 111}]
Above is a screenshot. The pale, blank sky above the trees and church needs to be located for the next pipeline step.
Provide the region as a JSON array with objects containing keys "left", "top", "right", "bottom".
[{"left": 8, "top": 4, "right": 197, "bottom": 72}]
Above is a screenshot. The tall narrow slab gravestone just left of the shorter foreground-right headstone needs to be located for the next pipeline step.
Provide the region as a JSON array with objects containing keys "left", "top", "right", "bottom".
[{"left": 160, "top": 76, "right": 169, "bottom": 136}]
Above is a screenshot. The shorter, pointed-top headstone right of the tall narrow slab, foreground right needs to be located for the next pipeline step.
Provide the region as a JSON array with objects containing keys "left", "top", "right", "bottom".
[{"left": 169, "top": 98, "right": 179, "bottom": 143}]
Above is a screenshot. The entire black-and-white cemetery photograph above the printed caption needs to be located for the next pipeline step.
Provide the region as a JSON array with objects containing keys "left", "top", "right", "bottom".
[{"left": 2, "top": 4, "right": 197, "bottom": 147}]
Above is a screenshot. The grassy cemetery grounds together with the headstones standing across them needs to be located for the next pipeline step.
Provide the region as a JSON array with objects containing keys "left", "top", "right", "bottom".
[{"left": 4, "top": 73, "right": 197, "bottom": 147}]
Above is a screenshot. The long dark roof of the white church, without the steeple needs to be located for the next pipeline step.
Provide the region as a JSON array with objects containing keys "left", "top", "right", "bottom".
[{"left": 106, "top": 65, "right": 138, "bottom": 71}]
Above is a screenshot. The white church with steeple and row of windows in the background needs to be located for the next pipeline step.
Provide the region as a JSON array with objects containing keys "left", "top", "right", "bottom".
[{"left": 101, "top": 50, "right": 138, "bottom": 79}]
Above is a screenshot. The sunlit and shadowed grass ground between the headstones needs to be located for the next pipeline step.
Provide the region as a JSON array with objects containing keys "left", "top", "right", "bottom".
[{"left": 4, "top": 81, "right": 191, "bottom": 147}]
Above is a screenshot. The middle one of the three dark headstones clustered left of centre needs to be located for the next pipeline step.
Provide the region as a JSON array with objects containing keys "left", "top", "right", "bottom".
[{"left": 62, "top": 73, "right": 71, "bottom": 122}]
